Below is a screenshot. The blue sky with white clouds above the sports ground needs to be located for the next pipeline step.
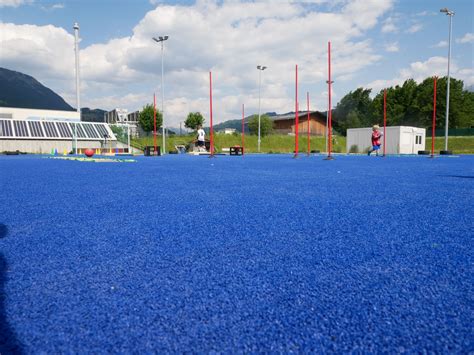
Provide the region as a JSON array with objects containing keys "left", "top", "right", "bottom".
[{"left": 0, "top": 0, "right": 474, "bottom": 127}]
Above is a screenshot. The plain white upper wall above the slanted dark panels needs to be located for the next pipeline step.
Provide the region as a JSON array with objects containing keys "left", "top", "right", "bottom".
[{"left": 0, "top": 107, "right": 80, "bottom": 121}]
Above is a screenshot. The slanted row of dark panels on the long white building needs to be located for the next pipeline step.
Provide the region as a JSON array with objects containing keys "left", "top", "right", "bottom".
[{"left": 0, "top": 119, "right": 116, "bottom": 140}]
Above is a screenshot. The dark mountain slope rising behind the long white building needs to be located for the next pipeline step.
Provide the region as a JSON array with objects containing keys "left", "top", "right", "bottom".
[{"left": 0, "top": 67, "right": 74, "bottom": 111}]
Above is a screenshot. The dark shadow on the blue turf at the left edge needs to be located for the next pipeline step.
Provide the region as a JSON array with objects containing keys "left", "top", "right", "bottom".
[{"left": 0, "top": 223, "right": 23, "bottom": 355}]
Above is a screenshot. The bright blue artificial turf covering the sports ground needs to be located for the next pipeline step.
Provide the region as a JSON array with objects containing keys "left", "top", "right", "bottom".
[{"left": 0, "top": 155, "right": 474, "bottom": 353}]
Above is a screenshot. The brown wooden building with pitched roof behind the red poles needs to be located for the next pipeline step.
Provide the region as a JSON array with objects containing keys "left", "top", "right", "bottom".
[{"left": 270, "top": 111, "right": 326, "bottom": 136}]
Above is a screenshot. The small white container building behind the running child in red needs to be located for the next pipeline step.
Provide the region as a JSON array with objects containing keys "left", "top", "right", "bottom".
[{"left": 346, "top": 126, "right": 426, "bottom": 154}]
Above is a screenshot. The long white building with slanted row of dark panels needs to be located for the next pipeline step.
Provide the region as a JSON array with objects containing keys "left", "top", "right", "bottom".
[{"left": 0, "top": 107, "right": 116, "bottom": 153}]
